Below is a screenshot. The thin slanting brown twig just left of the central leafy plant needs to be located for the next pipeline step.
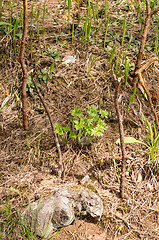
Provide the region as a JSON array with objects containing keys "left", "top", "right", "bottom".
[{"left": 32, "top": 76, "right": 64, "bottom": 179}]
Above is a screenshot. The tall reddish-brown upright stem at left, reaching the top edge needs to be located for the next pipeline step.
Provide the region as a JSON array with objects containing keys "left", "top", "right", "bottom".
[{"left": 20, "top": 0, "right": 28, "bottom": 130}]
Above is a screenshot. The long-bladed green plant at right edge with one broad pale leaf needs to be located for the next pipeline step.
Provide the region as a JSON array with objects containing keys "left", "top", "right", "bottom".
[{"left": 116, "top": 114, "right": 159, "bottom": 163}]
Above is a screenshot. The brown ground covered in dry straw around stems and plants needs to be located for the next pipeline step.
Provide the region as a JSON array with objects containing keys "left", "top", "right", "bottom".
[{"left": 0, "top": 0, "right": 159, "bottom": 240}]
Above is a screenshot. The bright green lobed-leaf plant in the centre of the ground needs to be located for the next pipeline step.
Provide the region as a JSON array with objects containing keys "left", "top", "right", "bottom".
[{"left": 54, "top": 105, "right": 108, "bottom": 143}]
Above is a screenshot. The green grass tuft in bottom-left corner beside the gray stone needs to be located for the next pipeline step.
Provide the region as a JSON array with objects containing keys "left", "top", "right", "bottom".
[{"left": 0, "top": 194, "right": 63, "bottom": 240}]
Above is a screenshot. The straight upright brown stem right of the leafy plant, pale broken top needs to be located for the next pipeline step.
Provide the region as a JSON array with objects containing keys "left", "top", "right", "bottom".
[{"left": 114, "top": 77, "right": 126, "bottom": 198}]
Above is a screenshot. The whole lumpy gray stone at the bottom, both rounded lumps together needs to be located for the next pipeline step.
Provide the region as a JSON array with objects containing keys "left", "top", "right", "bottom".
[{"left": 22, "top": 187, "right": 103, "bottom": 237}]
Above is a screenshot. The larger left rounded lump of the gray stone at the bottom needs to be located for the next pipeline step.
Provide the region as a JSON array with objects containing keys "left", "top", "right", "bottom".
[{"left": 22, "top": 190, "right": 74, "bottom": 237}]
